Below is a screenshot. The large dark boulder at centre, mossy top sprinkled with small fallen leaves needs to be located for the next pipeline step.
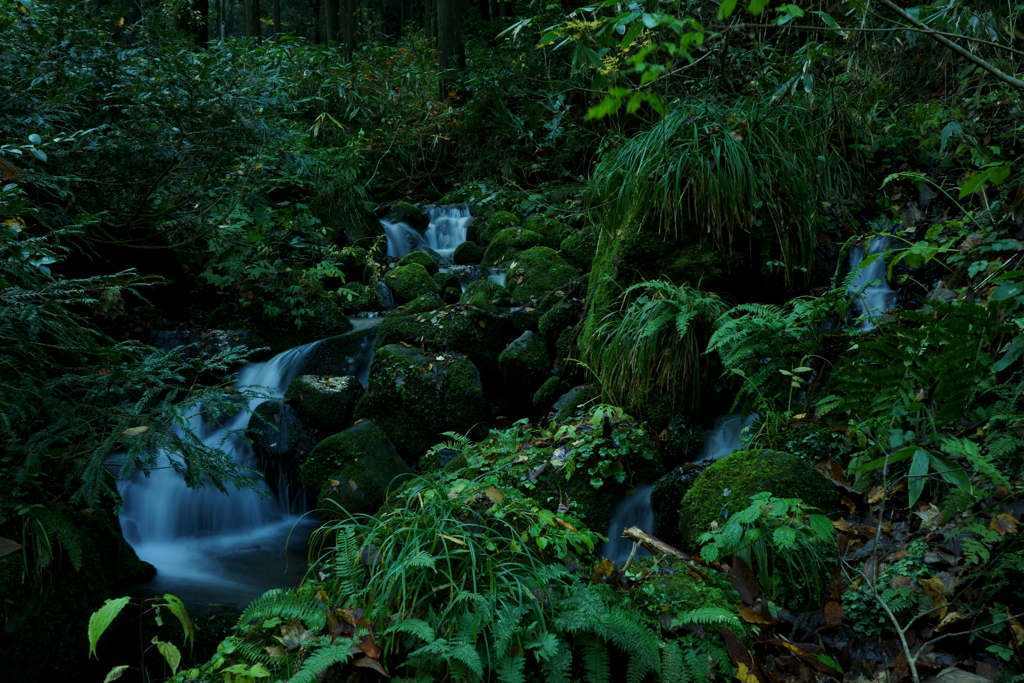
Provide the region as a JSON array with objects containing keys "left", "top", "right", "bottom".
[{"left": 355, "top": 344, "right": 489, "bottom": 460}]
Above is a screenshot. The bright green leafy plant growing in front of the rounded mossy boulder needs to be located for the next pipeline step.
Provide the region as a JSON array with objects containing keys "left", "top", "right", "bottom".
[{"left": 698, "top": 493, "right": 836, "bottom": 604}]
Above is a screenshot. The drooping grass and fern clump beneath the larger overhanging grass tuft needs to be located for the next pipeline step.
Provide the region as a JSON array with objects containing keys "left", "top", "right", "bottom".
[{"left": 583, "top": 281, "right": 726, "bottom": 417}]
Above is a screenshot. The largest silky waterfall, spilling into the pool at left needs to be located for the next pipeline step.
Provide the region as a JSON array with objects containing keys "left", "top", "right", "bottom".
[{"left": 120, "top": 343, "right": 315, "bottom": 604}]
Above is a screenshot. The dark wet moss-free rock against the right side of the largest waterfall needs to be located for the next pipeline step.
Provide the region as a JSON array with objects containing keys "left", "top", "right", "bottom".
[{"left": 246, "top": 400, "right": 316, "bottom": 500}]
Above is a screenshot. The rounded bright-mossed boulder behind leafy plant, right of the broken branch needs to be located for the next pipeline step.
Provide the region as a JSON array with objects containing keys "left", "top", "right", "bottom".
[{"left": 679, "top": 451, "right": 839, "bottom": 550}]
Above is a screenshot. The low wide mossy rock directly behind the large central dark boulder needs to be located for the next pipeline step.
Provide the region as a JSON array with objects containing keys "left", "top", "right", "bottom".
[{"left": 377, "top": 304, "right": 510, "bottom": 377}]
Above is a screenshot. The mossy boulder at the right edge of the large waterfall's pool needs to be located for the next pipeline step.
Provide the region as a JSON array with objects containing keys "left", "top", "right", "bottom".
[{"left": 302, "top": 420, "right": 413, "bottom": 519}]
